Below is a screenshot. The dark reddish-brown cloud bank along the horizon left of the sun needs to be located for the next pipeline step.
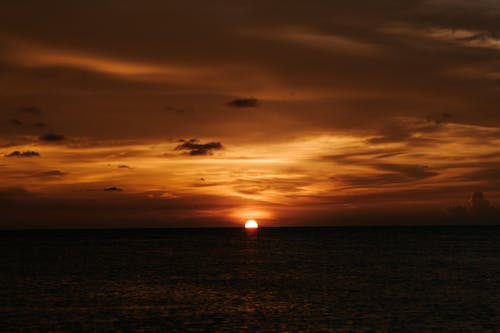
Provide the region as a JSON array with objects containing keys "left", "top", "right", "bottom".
[{"left": 0, "top": 188, "right": 241, "bottom": 228}]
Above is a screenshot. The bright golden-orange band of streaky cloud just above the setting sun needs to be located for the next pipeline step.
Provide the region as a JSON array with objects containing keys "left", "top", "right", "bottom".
[{"left": 2, "top": 118, "right": 500, "bottom": 224}]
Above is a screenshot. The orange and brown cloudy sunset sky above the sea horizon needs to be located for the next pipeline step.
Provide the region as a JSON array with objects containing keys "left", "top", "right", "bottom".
[{"left": 0, "top": 0, "right": 500, "bottom": 228}]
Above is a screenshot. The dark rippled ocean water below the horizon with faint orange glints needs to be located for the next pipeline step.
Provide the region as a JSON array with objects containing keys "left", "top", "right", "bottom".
[{"left": 0, "top": 226, "right": 500, "bottom": 332}]
